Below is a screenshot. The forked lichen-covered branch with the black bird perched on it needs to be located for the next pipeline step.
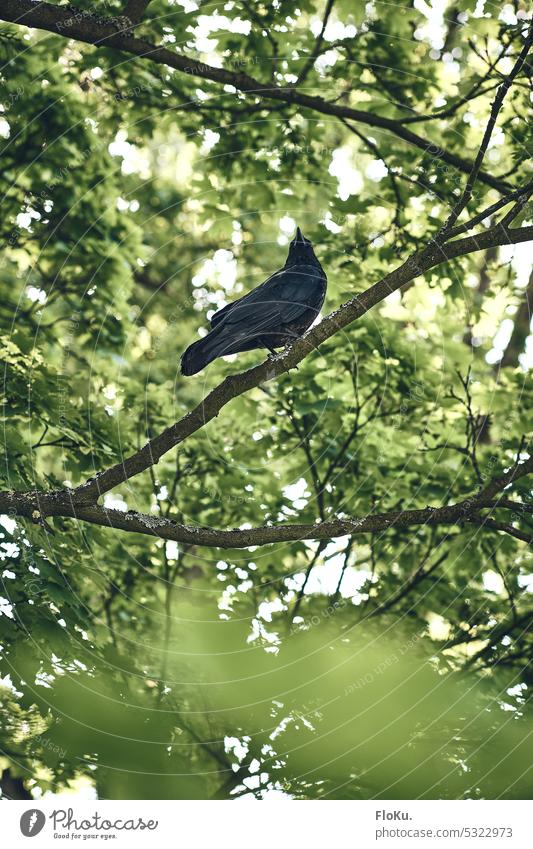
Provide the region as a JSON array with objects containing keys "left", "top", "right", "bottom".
[{"left": 0, "top": 219, "right": 533, "bottom": 548}]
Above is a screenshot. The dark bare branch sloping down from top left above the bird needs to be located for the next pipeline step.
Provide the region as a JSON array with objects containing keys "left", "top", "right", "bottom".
[{"left": 0, "top": 0, "right": 509, "bottom": 192}]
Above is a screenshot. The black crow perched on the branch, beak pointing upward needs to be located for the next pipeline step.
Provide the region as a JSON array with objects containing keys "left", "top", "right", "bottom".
[{"left": 181, "top": 227, "right": 327, "bottom": 375}]
